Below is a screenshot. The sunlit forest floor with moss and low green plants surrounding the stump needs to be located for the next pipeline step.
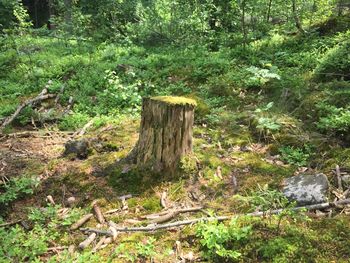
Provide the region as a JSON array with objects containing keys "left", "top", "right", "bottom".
[{"left": 0, "top": 16, "right": 350, "bottom": 262}]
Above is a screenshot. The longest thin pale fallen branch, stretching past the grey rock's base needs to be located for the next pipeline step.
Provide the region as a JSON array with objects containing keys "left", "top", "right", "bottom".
[{"left": 80, "top": 199, "right": 350, "bottom": 236}]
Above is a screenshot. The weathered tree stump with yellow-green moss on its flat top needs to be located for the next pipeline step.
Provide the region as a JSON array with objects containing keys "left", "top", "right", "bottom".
[{"left": 131, "top": 96, "right": 196, "bottom": 172}]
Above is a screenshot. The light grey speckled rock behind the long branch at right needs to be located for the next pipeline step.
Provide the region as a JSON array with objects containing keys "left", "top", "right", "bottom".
[{"left": 283, "top": 174, "right": 329, "bottom": 205}]
